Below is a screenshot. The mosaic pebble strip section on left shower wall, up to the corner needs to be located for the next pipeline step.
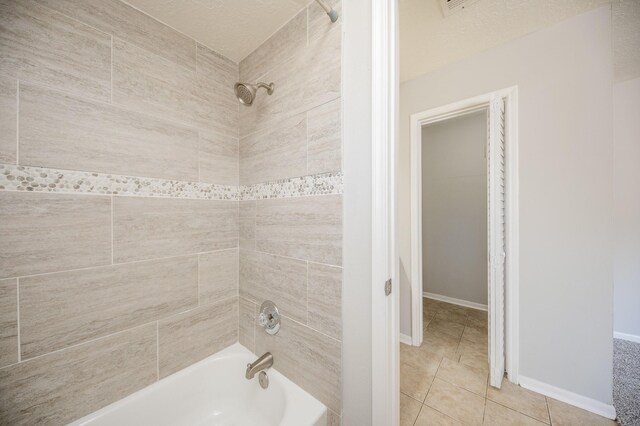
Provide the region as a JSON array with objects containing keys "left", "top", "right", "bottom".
[{"left": 0, "top": 164, "right": 238, "bottom": 200}]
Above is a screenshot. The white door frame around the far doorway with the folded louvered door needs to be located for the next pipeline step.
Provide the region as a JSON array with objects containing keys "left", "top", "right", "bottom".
[{"left": 410, "top": 86, "right": 519, "bottom": 383}]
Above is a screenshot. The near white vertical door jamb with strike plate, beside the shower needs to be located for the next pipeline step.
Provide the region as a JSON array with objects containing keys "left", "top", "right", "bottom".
[{"left": 371, "top": 0, "right": 400, "bottom": 426}]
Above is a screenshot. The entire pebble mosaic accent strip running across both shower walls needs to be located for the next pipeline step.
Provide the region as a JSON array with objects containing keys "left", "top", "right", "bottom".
[{"left": 0, "top": 164, "right": 343, "bottom": 200}]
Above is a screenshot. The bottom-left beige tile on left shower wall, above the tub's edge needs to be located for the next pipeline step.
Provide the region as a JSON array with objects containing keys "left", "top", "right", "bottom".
[{"left": 0, "top": 324, "right": 157, "bottom": 425}]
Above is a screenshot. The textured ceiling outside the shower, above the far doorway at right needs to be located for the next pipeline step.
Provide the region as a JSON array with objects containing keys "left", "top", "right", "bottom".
[{"left": 399, "top": 0, "right": 640, "bottom": 81}]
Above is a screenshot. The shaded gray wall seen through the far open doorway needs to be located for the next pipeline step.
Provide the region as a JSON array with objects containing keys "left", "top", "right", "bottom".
[{"left": 422, "top": 111, "right": 487, "bottom": 305}]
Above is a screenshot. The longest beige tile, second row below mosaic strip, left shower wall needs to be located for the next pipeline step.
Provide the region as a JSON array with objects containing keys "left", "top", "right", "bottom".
[{"left": 20, "top": 256, "right": 198, "bottom": 359}]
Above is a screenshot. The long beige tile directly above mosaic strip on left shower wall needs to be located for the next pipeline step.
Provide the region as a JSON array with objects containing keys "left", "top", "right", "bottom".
[{"left": 20, "top": 84, "right": 198, "bottom": 181}]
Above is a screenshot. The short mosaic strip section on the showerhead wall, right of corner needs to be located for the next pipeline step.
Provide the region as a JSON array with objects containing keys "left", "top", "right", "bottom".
[{"left": 239, "top": 173, "right": 343, "bottom": 200}]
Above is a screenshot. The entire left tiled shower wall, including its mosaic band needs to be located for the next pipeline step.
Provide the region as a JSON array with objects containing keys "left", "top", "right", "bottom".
[{"left": 0, "top": 0, "right": 239, "bottom": 424}]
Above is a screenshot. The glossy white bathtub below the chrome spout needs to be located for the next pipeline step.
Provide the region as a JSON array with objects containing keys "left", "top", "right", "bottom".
[{"left": 71, "top": 343, "right": 327, "bottom": 426}]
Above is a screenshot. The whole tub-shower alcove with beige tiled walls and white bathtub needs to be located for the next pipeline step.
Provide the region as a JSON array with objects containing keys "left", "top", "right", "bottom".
[{"left": 0, "top": 0, "right": 343, "bottom": 426}]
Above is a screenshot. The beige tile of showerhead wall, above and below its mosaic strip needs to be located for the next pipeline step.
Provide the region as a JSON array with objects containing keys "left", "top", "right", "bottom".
[{"left": 239, "top": 1, "right": 342, "bottom": 424}]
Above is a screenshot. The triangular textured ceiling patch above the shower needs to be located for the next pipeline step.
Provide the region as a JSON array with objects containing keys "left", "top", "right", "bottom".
[{"left": 125, "top": 0, "right": 312, "bottom": 62}]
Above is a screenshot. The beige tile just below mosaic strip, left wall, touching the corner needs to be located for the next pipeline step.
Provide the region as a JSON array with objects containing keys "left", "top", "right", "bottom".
[{"left": 113, "top": 197, "right": 238, "bottom": 263}]
